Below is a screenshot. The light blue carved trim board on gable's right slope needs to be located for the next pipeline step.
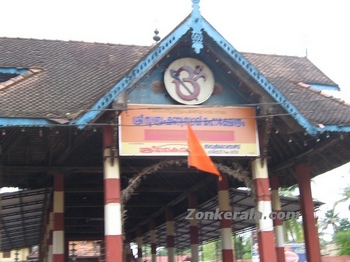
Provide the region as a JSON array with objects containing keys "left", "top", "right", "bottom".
[{"left": 203, "top": 21, "right": 319, "bottom": 135}]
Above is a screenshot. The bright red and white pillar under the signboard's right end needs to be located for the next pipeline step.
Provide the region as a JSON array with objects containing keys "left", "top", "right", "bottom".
[{"left": 252, "top": 158, "right": 277, "bottom": 262}]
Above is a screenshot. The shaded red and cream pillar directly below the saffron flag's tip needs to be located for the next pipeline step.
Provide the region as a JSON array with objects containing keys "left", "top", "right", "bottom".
[{"left": 218, "top": 174, "right": 234, "bottom": 262}]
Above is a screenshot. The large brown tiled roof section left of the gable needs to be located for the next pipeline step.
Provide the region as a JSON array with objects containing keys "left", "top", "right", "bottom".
[{"left": 0, "top": 38, "right": 150, "bottom": 118}]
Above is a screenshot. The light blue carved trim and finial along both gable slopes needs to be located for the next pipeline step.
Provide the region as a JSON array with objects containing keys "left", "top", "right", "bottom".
[{"left": 70, "top": 10, "right": 350, "bottom": 135}]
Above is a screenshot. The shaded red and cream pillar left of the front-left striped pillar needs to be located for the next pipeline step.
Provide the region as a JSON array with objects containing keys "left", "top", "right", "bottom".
[{"left": 52, "top": 174, "right": 65, "bottom": 262}]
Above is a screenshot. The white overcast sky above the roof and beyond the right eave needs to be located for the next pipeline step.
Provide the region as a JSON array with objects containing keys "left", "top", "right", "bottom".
[{"left": 0, "top": 0, "right": 350, "bottom": 215}]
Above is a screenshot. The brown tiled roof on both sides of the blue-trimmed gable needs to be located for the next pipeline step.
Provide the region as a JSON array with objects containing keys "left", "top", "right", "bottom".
[{"left": 0, "top": 38, "right": 350, "bottom": 125}]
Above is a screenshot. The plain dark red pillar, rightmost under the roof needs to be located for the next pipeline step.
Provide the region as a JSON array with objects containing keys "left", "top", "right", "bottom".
[{"left": 295, "top": 164, "right": 321, "bottom": 262}]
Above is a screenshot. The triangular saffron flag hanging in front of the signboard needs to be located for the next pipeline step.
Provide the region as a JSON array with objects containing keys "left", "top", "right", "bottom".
[{"left": 187, "top": 123, "right": 222, "bottom": 181}]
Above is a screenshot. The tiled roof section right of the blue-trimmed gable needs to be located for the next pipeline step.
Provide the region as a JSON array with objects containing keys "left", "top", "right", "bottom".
[{"left": 243, "top": 53, "right": 350, "bottom": 126}]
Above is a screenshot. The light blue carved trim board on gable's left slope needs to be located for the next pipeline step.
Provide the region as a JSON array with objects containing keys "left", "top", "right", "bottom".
[{"left": 71, "top": 18, "right": 190, "bottom": 129}]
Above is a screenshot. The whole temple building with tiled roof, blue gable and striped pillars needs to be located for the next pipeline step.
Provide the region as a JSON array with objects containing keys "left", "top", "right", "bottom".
[{"left": 0, "top": 0, "right": 350, "bottom": 262}]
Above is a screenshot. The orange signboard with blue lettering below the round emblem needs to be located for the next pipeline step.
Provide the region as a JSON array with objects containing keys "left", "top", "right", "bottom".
[{"left": 119, "top": 105, "right": 259, "bottom": 156}]
